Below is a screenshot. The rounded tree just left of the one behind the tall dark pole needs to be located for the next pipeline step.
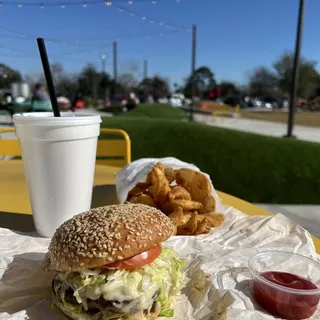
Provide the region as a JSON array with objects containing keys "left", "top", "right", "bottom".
[{"left": 249, "top": 67, "right": 278, "bottom": 97}]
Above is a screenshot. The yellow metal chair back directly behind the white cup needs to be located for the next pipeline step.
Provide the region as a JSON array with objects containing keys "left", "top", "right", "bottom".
[{"left": 0, "top": 128, "right": 131, "bottom": 168}]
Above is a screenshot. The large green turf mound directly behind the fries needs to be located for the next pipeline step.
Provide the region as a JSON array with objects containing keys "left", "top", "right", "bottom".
[{"left": 102, "top": 117, "right": 320, "bottom": 204}]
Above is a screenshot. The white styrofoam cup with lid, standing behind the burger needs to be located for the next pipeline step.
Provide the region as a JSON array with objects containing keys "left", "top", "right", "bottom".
[{"left": 13, "top": 112, "right": 101, "bottom": 238}]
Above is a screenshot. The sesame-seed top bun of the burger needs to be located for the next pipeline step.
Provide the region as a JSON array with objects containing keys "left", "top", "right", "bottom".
[{"left": 42, "top": 204, "right": 173, "bottom": 272}]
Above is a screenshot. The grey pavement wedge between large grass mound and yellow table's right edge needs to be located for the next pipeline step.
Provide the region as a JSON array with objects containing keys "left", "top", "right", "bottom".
[{"left": 257, "top": 204, "right": 320, "bottom": 238}]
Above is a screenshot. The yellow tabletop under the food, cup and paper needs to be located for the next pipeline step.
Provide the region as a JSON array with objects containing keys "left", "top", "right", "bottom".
[{"left": 0, "top": 160, "right": 320, "bottom": 253}]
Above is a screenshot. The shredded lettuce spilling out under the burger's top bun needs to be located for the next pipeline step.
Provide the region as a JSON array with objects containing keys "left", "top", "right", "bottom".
[{"left": 54, "top": 248, "right": 185, "bottom": 320}]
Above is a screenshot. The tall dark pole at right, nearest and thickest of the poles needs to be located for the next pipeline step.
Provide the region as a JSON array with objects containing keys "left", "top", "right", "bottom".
[{"left": 284, "top": 0, "right": 305, "bottom": 138}]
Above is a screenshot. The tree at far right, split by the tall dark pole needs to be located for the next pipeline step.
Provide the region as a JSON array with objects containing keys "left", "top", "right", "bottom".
[{"left": 273, "top": 52, "right": 320, "bottom": 99}]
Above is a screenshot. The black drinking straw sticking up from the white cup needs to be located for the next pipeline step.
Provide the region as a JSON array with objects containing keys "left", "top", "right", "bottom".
[{"left": 37, "top": 38, "right": 61, "bottom": 117}]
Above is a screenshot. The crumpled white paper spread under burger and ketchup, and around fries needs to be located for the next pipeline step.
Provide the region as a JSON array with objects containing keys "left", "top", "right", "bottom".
[{"left": 0, "top": 158, "right": 320, "bottom": 320}]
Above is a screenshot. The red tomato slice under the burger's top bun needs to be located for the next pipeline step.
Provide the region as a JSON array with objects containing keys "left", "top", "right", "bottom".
[{"left": 102, "top": 244, "right": 162, "bottom": 270}]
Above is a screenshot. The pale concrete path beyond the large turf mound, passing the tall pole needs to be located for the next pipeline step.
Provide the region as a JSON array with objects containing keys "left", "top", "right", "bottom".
[{"left": 195, "top": 114, "right": 320, "bottom": 142}]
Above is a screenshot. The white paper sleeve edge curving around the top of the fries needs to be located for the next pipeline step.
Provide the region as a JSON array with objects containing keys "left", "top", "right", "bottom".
[{"left": 116, "top": 157, "right": 224, "bottom": 213}]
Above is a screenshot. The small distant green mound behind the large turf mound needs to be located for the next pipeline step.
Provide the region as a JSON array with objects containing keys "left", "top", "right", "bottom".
[{"left": 118, "top": 103, "right": 187, "bottom": 120}]
